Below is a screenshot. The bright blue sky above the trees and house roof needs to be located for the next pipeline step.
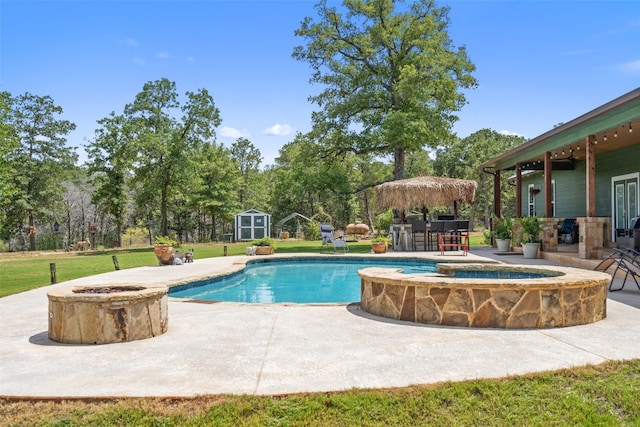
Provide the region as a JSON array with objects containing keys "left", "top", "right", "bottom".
[{"left": 0, "top": 0, "right": 640, "bottom": 164}]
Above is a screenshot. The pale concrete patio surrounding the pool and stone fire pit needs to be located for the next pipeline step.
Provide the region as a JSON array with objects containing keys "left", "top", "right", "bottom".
[{"left": 0, "top": 248, "right": 640, "bottom": 397}]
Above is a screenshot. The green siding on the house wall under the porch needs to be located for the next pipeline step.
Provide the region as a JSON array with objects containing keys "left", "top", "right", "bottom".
[{"left": 522, "top": 145, "right": 640, "bottom": 218}]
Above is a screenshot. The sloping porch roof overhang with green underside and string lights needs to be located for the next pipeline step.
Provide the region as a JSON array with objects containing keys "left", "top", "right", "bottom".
[{"left": 482, "top": 88, "right": 640, "bottom": 170}]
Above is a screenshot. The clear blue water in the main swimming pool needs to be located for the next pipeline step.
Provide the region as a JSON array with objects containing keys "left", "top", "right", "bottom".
[{"left": 169, "top": 259, "right": 436, "bottom": 304}]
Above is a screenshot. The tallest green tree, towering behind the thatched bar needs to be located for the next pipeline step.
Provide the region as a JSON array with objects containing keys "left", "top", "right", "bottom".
[{"left": 293, "top": 0, "right": 476, "bottom": 179}]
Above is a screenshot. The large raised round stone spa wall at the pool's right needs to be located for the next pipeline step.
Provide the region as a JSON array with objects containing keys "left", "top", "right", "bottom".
[{"left": 358, "top": 264, "right": 611, "bottom": 328}]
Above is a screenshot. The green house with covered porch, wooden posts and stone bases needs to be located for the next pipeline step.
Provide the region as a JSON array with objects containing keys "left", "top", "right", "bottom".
[{"left": 482, "top": 88, "right": 640, "bottom": 259}]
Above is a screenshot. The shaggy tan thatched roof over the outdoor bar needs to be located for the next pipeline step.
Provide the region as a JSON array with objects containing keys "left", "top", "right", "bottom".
[{"left": 375, "top": 176, "right": 478, "bottom": 211}]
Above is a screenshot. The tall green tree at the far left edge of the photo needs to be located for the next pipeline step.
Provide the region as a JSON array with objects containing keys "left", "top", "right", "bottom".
[{"left": 3, "top": 93, "right": 77, "bottom": 251}]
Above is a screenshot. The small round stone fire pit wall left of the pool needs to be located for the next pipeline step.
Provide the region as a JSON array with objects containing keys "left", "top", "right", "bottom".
[{"left": 47, "top": 284, "right": 169, "bottom": 344}]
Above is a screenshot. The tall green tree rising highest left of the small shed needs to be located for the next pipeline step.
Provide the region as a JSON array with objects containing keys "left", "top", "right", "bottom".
[{"left": 124, "top": 78, "right": 221, "bottom": 235}]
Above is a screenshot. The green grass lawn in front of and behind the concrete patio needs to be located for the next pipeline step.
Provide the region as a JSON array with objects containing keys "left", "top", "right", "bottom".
[{"left": 0, "top": 235, "right": 640, "bottom": 426}]
